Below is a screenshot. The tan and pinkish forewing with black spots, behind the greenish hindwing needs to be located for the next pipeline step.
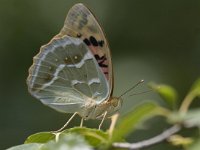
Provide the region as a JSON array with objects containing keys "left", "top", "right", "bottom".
[{"left": 57, "top": 4, "right": 113, "bottom": 98}]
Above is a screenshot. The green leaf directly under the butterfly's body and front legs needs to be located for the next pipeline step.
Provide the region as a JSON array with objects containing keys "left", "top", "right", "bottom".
[{"left": 61, "top": 127, "right": 108, "bottom": 147}]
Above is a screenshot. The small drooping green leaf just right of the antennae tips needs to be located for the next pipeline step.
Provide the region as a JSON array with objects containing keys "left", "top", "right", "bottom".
[{"left": 149, "top": 83, "right": 178, "bottom": 109}]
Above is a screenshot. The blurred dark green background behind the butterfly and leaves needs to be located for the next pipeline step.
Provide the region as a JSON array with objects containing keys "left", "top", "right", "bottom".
[{"left": 0, "top": 0, "right": 200, "bottom": 149}]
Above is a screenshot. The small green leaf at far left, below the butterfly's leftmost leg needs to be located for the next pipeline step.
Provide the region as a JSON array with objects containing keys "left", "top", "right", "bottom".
[{"left": 24, "top": 132, "right": 55, "bottom": 143}]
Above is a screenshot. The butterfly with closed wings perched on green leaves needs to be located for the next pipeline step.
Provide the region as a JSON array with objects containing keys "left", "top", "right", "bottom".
[{"left": 27, "top": 3, "right": 123, "bottom": 128}]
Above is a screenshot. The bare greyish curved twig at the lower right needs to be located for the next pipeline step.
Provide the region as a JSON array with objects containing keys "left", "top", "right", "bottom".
[{"left": 113, "top": 125, "right": 181, "bottom": 150}]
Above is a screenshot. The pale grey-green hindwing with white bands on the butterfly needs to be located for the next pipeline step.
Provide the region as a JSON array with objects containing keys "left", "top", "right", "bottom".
[{"left": 27, "top": 36, "right": 109, "bottom": 113}]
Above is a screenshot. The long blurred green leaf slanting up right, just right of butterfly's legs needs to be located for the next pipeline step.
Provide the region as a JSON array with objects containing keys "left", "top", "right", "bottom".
[{"left": 111, "top": 102, "right": 158, "bottom": 142}]
